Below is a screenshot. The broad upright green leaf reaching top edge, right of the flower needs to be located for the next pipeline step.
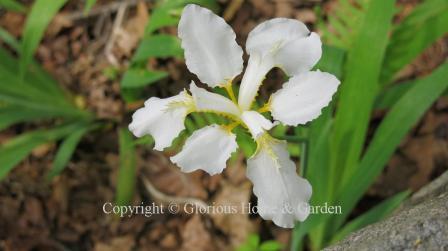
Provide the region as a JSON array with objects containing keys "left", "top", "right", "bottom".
[{"left": 331, "top": 0, "right": 395, "bottom": 188}]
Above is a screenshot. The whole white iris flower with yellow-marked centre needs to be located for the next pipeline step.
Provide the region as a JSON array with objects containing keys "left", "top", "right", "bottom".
[{"left": 129, "top": 4, "right": 339, "bottom": 227}]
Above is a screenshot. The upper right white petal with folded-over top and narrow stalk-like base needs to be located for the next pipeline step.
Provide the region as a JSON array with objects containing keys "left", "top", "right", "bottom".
[{"left": 238, "top": 18, "right": 322, "bottom": 110}]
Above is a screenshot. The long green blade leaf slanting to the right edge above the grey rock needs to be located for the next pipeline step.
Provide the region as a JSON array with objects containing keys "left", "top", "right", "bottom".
[{"left": 337, "top": 63, "right": 448, "bottom": 231}]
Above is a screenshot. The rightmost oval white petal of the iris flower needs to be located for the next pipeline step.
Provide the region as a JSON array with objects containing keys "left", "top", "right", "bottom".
[{"left": 270, "top": 71, "right": 340, "bottom": 126}]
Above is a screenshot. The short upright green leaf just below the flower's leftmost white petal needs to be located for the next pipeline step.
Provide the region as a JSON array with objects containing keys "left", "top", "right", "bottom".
[{"left": 116, "top": 128, "right": 137, "bottom": 205}]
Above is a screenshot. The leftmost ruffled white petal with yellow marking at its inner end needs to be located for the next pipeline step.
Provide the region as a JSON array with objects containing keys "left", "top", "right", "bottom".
[{"left": 129, "top": 91, "right": 192, "bottom": 151}]
